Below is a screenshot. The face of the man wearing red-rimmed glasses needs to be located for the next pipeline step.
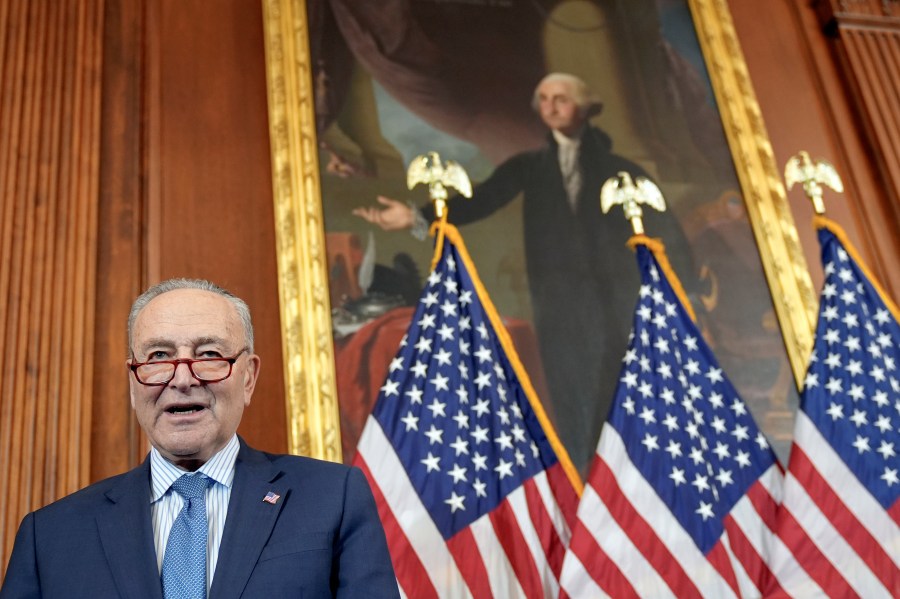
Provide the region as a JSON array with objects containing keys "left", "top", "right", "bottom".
[{"left": 129, "top": 289, "right": 259, "bottom": 470}]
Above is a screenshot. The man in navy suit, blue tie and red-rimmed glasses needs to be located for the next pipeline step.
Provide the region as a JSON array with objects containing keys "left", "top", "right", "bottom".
[{"left": 0, "top": 279, "right": 398, "bottom": 599}]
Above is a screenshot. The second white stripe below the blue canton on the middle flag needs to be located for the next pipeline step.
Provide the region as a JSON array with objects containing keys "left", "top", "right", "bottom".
[{"left": 562, "top": 485, "right": 675, "bottom": 598}]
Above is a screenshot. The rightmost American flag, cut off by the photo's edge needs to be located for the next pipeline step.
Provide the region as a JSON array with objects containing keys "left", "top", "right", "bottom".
[{"left": 773, "top": 217, "right": 900, "bottom": 598}]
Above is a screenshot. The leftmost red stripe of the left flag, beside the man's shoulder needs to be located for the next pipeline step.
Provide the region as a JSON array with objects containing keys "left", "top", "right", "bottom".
[{"left": 353, "top": 453, "right": 438, "bottom": 599}]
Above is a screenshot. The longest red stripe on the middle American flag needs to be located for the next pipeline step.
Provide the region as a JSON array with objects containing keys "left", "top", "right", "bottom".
[{"left": 588, "top": 459, "right": 702, "bottom": 597}]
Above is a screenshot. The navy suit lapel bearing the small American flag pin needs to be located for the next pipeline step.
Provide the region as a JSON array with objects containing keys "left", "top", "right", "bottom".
[{"left": 209, "top": 439, "right": 289, "bottom": 599}]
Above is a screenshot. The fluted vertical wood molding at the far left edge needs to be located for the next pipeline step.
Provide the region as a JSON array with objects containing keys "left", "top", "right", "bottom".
[{"left": 0, "top": 0, "right": 103, "bottom": 570}]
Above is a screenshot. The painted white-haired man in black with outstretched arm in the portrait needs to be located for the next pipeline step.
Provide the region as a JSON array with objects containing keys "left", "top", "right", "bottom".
[{"left": 354, "top": 73, "right": 692, "bottom": 472}]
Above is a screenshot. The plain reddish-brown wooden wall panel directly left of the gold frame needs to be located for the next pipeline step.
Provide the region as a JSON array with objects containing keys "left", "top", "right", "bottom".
[{"left": 147, "top": 0, "right": 287, "bottom": 452}]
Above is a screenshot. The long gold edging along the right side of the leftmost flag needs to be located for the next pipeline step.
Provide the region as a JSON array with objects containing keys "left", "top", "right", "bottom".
[{"left": 431, "top": 223, "right": 584, "bottom": 497}]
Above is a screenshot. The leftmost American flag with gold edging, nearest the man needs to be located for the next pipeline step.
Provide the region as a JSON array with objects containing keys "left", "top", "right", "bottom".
[{"left": 354, "top": 225, "right": 581, "bottom": 599}]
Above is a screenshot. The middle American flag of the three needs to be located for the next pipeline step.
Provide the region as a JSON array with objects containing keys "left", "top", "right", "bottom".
[{"left": 561, "top": 236, "right": 782, "bottom": 597}]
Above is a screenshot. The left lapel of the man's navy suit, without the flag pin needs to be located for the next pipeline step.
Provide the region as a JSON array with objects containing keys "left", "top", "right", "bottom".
[{"left": 97, "top": 459, "right": 162, "bottom": 599}]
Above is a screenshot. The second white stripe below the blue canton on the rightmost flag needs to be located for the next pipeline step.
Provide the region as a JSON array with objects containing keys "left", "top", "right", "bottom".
[{"left": 784, "top": 472, "right": 890, "bottom": 598}]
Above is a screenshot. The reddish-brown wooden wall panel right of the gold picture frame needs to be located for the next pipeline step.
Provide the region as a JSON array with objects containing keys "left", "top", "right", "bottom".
[{"left": 729, "top": 0, "right": 900, "bottom": 298}]
